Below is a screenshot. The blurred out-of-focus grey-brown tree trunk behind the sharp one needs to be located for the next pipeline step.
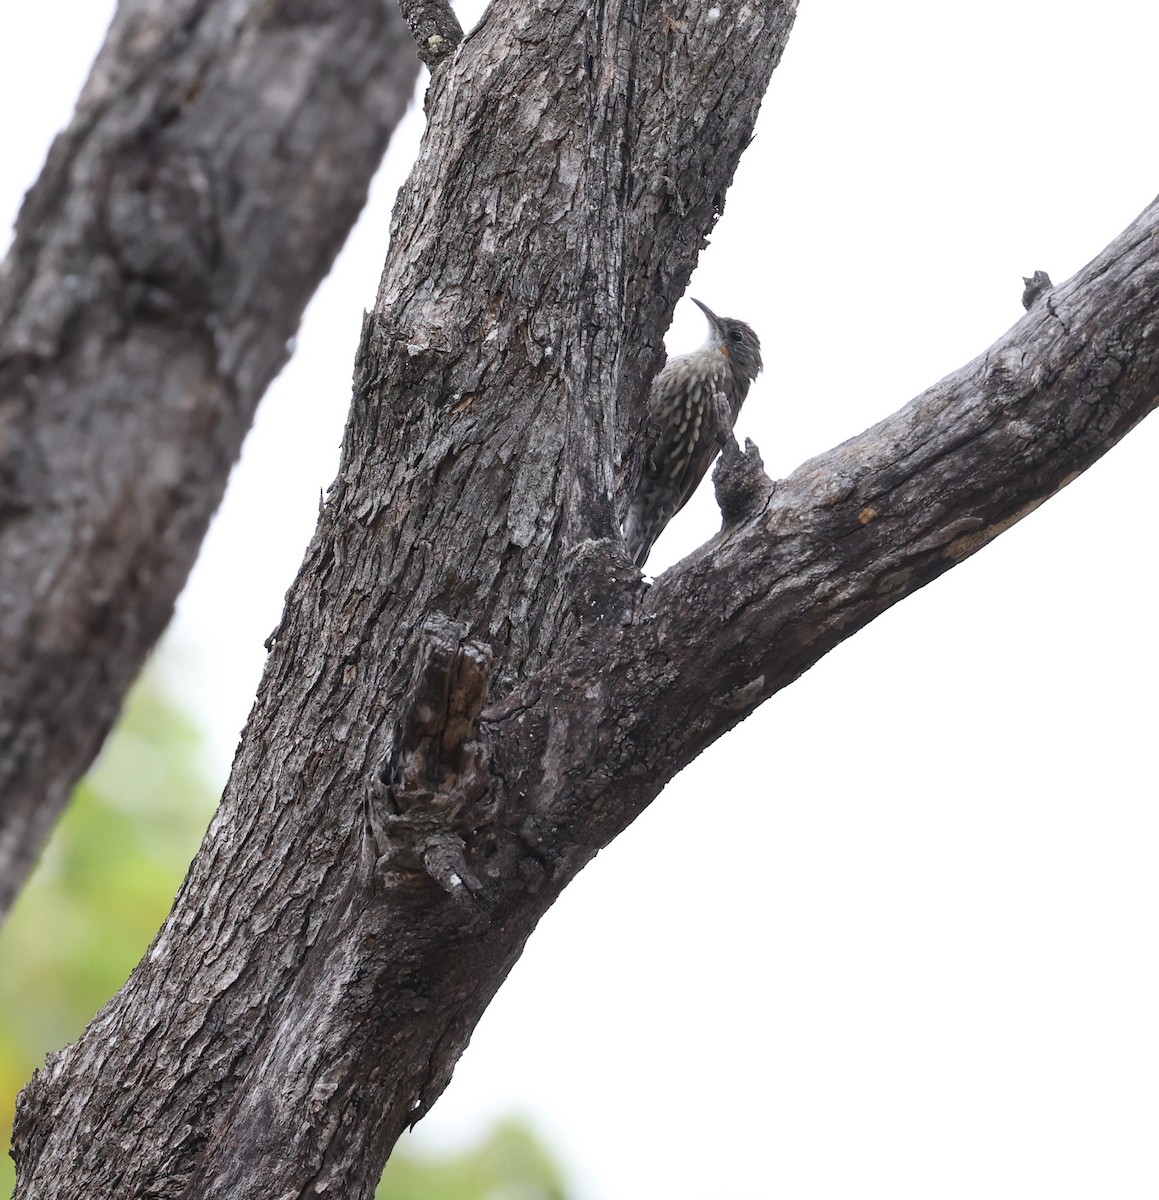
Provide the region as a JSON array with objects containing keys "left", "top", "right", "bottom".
[{"left": 0, "top": 0, "right": 418, "bottom": 919}]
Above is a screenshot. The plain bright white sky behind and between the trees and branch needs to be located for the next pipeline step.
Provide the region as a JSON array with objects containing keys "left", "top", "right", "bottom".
[{"left": 0, "top": 0, "right": 1159, "bottom": 1200}]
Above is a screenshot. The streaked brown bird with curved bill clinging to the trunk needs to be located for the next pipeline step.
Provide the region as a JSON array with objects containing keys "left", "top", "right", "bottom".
[{"left": 623, "top": 300, "right": 764, "bottom": 566}]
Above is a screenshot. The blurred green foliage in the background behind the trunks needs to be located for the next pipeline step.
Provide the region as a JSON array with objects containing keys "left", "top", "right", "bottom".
[{"left": 0, "top": 672, "right": 566, "bottom": 1200}]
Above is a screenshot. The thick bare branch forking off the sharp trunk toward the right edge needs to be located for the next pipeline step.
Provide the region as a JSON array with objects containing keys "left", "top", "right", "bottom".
[{"left": 485, "top": 192, "right": 1159, "bottom": 862}]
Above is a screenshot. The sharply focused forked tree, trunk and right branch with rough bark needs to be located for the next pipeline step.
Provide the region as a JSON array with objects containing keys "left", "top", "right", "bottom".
[{"left": 9, "top": 0, "right": 1159, "bottom": 1200}]
